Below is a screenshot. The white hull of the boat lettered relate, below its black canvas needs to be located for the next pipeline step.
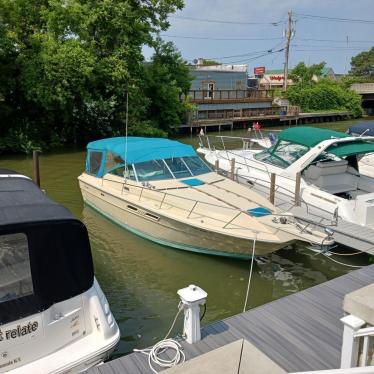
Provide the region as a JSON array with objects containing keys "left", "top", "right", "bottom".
[{"left": 4, "top": 280, "right": 120, "bottom": 374}]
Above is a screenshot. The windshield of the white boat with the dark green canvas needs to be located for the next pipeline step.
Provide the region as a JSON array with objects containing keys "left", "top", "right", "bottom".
[{"left": 254, "top": 140, "right": 309, "bottom": 169}]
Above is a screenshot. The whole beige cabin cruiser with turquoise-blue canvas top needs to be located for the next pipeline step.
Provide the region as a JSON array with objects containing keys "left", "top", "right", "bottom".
[{"left": 78, "top": 137, "right": 332, "bottom": 258}]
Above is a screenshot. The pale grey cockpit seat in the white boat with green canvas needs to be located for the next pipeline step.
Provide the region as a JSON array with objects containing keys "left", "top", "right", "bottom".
[{"left": 304, "top": 160, "right": 359, "bottom": 194}]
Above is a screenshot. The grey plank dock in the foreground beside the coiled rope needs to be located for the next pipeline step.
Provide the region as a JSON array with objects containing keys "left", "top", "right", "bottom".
[{"left": 88, "top": 265, "right": 374, "bottom": 374}]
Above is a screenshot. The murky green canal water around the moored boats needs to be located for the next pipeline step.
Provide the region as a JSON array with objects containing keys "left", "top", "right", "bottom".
[{"left": 0, "top": 121, "right": 369, "bottom": 356}]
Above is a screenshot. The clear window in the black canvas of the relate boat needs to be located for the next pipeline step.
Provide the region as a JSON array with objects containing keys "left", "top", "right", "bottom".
[{"left": 0, "top": 233, "right": 34, "bottom": 303}]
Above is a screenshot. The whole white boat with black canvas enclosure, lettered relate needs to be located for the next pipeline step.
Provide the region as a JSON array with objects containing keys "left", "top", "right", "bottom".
[{"left": 0, "top": 169, "right": 120, "bottom": 374}]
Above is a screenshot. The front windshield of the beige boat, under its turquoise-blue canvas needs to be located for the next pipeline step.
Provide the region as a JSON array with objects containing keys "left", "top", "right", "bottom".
[{"left": 131, "top": 156, "right": 211, "bottom": 182}]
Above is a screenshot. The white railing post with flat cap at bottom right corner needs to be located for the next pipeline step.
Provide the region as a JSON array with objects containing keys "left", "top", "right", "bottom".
[{"left": 340, "top": 314, "right": 366, "bottom": 369}]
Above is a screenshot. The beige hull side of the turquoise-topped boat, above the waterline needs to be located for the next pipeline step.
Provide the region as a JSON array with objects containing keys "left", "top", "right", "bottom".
[{"left": 79, "top": 179, "right": 294, "bottom": 259}]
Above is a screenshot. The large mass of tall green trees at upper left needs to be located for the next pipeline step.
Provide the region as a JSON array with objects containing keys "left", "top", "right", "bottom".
[{"left": 0, "top": 0, "right": 188, "bottom": 152}]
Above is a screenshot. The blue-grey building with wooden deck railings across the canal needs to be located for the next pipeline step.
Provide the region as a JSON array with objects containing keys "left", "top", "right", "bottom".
[{"left": 188, "top": 59, "right": 280, "bottom": 130}]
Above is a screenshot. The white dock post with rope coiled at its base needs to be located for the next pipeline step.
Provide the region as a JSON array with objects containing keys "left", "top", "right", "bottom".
[{"left": 177, "top": 284, "right": 208, "bottom": 344}]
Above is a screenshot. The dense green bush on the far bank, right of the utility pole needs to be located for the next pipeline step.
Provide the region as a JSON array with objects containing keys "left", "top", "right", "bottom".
[{"left": 287, "top": 79, "right": 362, "bottom": 117}]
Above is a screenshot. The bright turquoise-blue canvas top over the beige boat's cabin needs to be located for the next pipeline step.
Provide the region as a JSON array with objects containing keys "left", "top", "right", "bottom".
[{"left": 87, "top": 136, "right": 196, "bottom": 164}]
